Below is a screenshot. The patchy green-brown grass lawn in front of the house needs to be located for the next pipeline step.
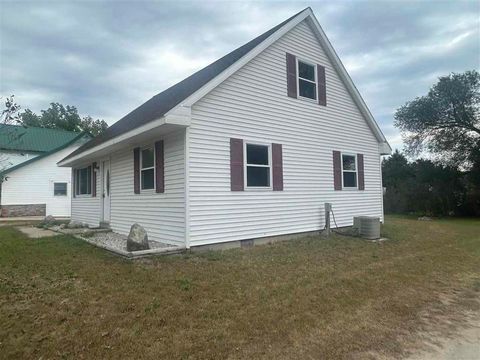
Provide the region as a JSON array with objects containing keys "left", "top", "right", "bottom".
[{"left": 0, "top": 217, "right": 480, "bottom": 359}]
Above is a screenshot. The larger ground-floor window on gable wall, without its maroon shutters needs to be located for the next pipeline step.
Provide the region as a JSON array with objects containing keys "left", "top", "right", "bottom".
[{"left": 245, "top": 144, "right": 271, "bottom": 187}]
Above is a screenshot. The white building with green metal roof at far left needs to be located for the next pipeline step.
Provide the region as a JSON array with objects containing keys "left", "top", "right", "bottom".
[{"left": 0, "top": 125, "right": 90, "bottom": 217}]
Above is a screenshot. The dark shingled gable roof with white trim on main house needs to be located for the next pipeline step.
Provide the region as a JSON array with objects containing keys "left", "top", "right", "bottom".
[{"left": 60, "top": 7, "right": 386, "bottom": 163}]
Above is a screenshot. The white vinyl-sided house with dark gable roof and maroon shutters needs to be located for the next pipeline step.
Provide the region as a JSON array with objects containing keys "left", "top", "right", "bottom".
[{"left": 59, "top": 8, "right": 391, "bottom": 248}]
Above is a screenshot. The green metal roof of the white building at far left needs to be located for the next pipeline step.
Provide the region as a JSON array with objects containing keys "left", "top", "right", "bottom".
[{"left": 0, "top": 124, "right": 79, "bottom": 152}]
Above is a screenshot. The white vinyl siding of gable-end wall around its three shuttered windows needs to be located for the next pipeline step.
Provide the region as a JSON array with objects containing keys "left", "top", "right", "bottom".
[{"left": 189, "top": 22, "right": 383, "bottom": 246}]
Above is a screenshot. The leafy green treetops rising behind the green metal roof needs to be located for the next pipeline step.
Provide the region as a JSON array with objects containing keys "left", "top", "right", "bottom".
[{"left": 22, "top": 103, "right": 108, "bottom": 136}]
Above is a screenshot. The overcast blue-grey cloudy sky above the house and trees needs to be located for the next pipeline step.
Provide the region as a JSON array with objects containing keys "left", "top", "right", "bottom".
[{"left": 0, "top": 0, "right": 480, "bottom": 147}]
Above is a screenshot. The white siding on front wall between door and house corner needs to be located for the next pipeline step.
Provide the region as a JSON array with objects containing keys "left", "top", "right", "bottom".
[{"left": 110, "top": 131, "right": 185, "bottom": 245}]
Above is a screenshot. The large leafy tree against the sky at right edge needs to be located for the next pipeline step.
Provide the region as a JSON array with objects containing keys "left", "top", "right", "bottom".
[{"left": 395, "top": 70, "right": 480, "bottom": 169}]
